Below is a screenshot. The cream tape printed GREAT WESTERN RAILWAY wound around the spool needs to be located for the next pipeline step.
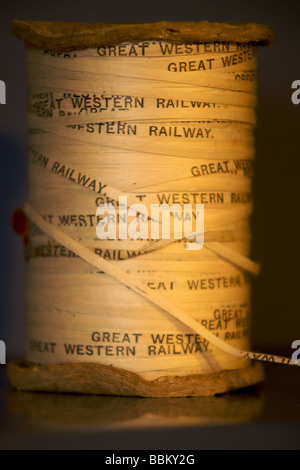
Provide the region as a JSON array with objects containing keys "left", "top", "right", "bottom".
[{"left": 24, "top": 42, "right": 298, "bottom": 379}]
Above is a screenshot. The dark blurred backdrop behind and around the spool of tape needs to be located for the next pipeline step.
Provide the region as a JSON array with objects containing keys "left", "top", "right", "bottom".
[{"left": 0, "top": 0, "right": 300, "bottom": 359}]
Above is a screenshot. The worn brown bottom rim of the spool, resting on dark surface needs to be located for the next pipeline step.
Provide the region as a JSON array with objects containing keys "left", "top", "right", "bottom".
[{"left": 8, "top": 360, "right": 264, "bottom": 397}]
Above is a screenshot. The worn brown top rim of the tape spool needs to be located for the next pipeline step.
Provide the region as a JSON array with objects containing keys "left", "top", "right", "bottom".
[{"left": 11, "top": 20, "right": 273, "bottom": 51}]
